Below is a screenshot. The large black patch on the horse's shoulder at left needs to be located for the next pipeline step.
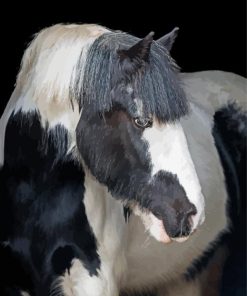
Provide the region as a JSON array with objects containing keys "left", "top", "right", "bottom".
[{"left": 0, "top": 112, "right": 100, "bottom": 296}]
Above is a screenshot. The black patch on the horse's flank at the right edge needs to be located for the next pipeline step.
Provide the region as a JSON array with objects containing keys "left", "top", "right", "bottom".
[{"left": 186, "top": 103, "right": 247, "bottom": 288}]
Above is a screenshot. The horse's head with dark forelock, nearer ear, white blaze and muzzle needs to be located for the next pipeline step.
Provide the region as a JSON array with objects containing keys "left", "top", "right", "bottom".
[{"left": 77, "top": 29, "right": 204, "bottom": 242}]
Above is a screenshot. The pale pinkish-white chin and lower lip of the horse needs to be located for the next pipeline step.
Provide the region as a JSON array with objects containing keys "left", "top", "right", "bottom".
[{"left": 134, "top": 207, "right": 189, "bottom": 244}]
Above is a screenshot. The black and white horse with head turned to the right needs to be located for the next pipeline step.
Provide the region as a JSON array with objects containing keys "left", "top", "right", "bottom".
[{"left": 0, "top": 24, "right": 247, "bottom": 296}]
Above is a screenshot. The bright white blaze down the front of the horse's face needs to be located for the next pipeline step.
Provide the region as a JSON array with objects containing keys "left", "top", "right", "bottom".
[{"left": 143, "top": 120, "right": 204, "bottom": 231}]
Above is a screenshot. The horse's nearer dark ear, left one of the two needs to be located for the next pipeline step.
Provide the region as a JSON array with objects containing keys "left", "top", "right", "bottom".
[{"left": 118, "top": 32, "right": 154, "bottom": 62}]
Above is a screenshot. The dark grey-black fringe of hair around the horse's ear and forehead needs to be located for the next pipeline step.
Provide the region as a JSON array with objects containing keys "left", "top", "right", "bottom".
[{"left": 71, "top": 33, "right": 189, "bottom": 122}]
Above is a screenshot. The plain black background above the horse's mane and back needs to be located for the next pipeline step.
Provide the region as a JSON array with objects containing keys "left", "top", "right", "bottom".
[{"left": 0, "top": 0, "right": 246, "bottom": 114}]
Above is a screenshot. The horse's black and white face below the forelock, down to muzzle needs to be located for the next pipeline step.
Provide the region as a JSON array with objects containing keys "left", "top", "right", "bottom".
[{"left": 77, "top": 94, "right": 204, "bottom": 242}]
